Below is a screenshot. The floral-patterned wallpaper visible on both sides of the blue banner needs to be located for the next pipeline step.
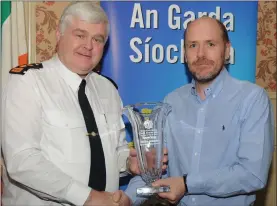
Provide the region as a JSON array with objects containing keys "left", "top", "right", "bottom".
[{"left": 36, "top": 1, "right": 277, "bottom": 92}]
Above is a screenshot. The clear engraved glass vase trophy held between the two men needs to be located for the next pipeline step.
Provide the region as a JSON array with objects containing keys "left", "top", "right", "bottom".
[{"left": 123, "top": 102, "right": 171, "bottom": 196}]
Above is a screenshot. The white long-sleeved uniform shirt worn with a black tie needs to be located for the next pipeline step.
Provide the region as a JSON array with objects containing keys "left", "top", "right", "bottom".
[{"left": 2, "top": 56, "right": 128, "bottom": 206}]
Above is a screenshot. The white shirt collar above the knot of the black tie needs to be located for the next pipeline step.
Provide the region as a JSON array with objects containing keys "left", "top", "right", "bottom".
[{"left": 53, "top": 54, "right": 93, "bottom": 91}]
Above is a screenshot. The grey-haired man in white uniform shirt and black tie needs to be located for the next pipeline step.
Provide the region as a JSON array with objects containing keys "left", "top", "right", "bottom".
[{"left": 2, "top": 2, "right": 129, "bottom": 206}]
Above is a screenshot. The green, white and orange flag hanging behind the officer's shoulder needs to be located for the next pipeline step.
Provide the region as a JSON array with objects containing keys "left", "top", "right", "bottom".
[{"left": 1, "top": 1, "right": 28, "bottom": 86}]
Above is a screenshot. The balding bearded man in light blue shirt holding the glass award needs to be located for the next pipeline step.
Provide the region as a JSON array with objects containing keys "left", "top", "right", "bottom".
[{"left": 126, "top": 17, "right": 274, "bottom": 206}]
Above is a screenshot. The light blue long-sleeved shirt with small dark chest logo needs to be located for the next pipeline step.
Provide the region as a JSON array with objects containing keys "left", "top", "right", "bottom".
[{"left": 126, "top": 69, "right": 274, "bottom": 206}]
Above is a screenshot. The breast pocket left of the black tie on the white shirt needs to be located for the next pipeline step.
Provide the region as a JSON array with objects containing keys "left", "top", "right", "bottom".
[{"left": 41, "top": 111, "right": 90, "bottom": 163}]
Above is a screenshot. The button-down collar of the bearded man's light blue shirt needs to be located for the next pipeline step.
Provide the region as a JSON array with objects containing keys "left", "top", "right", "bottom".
[{"left": 191, "top": 67, "right": 226, "bottom": 97}]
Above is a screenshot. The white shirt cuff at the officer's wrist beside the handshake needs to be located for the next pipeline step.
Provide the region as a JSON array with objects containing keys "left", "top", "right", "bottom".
[{"left": 66, "top": 181, "right": 91, "bottom": 205}]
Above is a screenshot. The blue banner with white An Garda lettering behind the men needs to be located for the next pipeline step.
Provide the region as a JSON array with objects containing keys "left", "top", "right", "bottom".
[{"left": 101, "top": 1, "right": 257, "bottom": 105}]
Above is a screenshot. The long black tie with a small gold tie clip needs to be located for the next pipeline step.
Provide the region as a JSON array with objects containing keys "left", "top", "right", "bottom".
[{"left": 78, "top": 79, "right": 106, "bottom": 191}]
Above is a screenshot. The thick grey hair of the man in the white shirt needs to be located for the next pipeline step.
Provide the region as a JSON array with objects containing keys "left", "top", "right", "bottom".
[{"left": 59, "top": 1, "right": 110, "bottom": 40}]
